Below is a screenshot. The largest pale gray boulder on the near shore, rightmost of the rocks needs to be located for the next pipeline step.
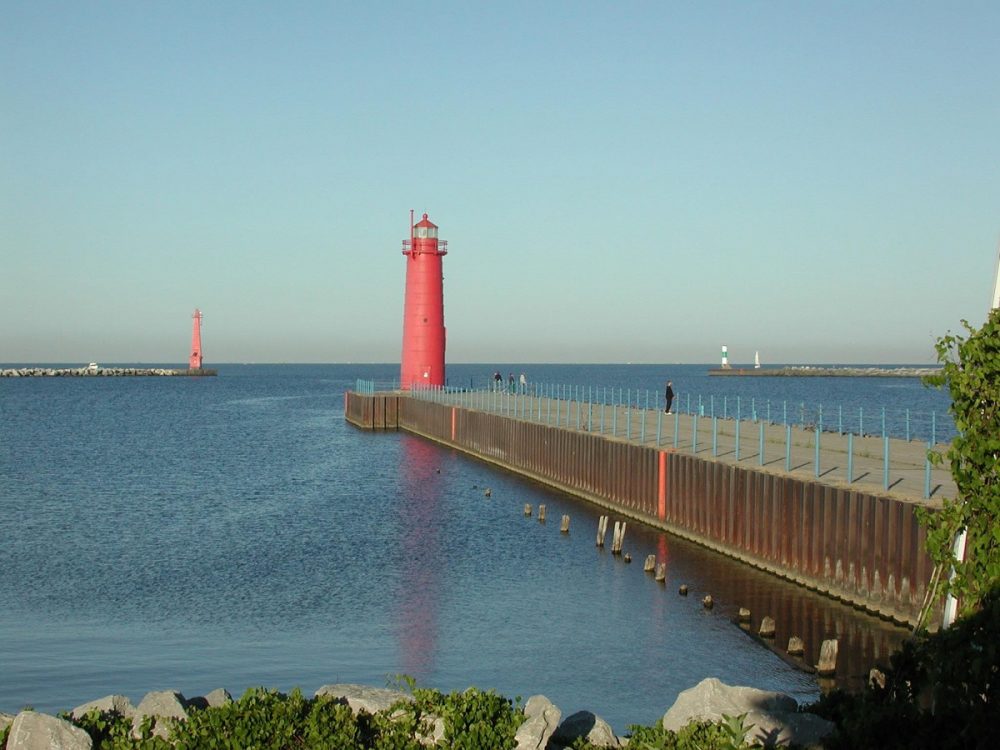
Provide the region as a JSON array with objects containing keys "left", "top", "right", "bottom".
[{"left": 663, "top": 677, "right": 834, "bottom": 747}]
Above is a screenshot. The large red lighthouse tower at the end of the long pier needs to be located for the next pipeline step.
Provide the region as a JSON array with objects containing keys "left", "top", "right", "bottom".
[{"left": 399, "top": 214, "right": 448, "bottom": 390}]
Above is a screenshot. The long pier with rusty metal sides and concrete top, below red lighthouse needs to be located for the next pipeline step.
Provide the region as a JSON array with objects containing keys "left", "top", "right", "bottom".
[{"left": 345, "top": 392, "right": 954, "bottom": 623}]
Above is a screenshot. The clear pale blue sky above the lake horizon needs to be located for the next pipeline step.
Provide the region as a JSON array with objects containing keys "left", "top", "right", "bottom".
[{"left": 0, "top": 0, "right": 1000, "bottom": 364}]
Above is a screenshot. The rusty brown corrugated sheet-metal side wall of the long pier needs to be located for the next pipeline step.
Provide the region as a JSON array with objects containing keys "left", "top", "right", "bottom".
[{"left": 344, "top": 392, "right": 932, "bottom": 624}]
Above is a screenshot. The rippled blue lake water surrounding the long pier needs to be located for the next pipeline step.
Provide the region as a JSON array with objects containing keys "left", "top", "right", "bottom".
[{"left": 0, "top": 365, "right": 947, "bottom": 733}]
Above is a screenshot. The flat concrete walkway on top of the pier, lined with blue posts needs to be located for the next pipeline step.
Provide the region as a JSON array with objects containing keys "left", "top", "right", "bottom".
[{"left": 411, "top": 389, "right": 956, "bottom": 506}]
